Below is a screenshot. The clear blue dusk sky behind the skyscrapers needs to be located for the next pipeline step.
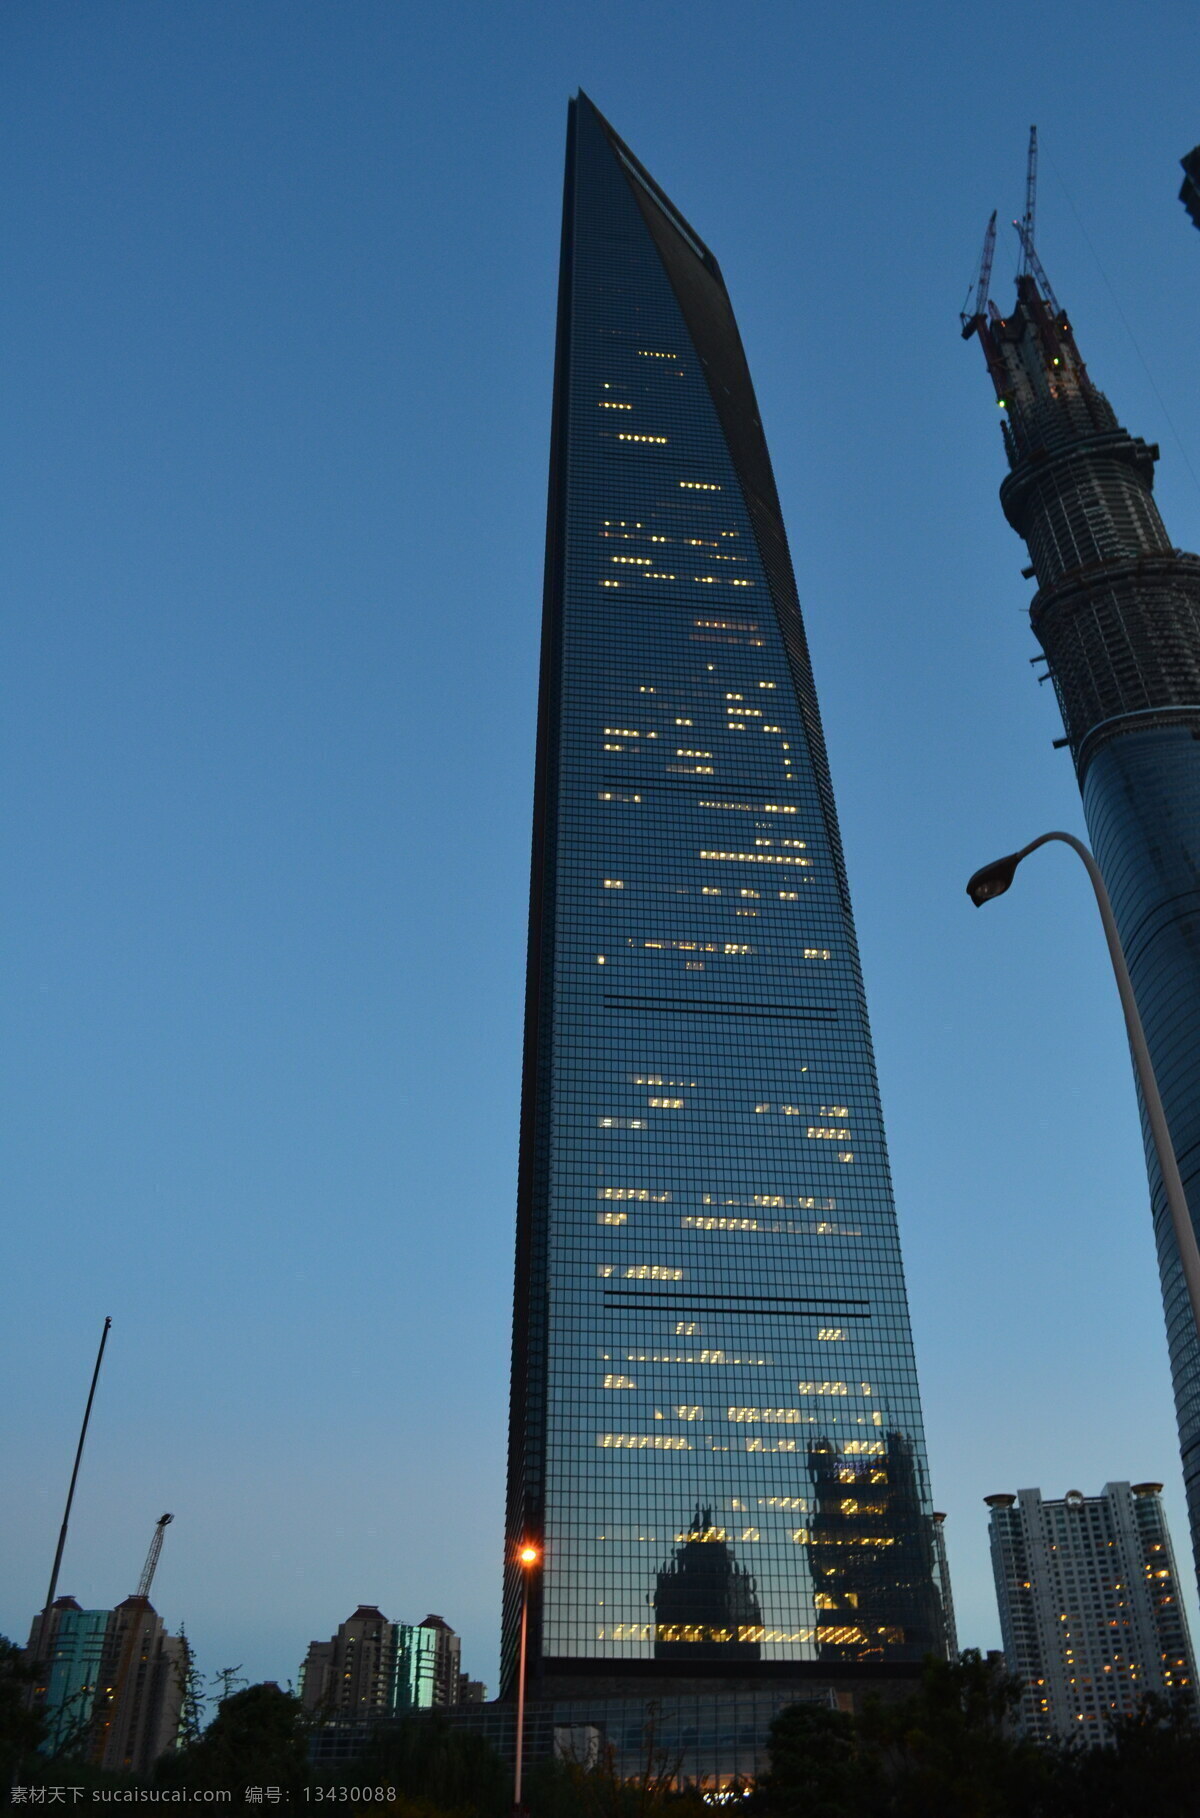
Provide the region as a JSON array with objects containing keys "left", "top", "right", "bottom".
[{"left": 0, "top": 0, "right": 1200, "bottom": 1687}]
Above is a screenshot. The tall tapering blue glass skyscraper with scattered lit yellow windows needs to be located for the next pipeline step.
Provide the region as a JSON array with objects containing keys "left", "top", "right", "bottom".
[{"left": 504, "top": 96, "right": 944, "bottom": 1694}]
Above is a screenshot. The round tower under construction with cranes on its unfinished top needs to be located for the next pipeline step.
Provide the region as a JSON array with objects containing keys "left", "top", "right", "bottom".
[{"left": 964, "top": 140, "right": 1200, "bottom": 1558}]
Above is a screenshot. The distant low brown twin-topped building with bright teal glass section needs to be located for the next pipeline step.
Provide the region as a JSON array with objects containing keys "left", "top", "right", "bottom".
[{"left": 300, "top": 1603, "right": 482, "bottom": 1722}]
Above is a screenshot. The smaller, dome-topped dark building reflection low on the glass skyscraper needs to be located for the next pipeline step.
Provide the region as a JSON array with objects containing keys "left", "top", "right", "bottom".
[{"left": 655, "top": 1509, "right": 762, "bottom": 1660}]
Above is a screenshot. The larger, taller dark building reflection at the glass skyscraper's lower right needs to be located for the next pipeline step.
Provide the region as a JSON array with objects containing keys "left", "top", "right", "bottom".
[{"left": 807, "top": 1433, "right": 949, "bottom": 1660}]
